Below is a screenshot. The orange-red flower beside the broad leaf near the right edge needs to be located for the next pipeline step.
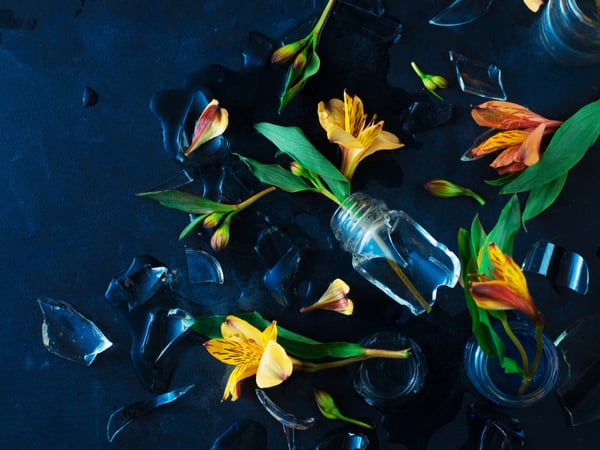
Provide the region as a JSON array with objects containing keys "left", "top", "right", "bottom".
[{"left": 463, "top": 100, "right": 562, "bottom": 175}]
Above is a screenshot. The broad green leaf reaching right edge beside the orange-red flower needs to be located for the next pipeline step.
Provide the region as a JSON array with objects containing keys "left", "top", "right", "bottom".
[{"left": 501, "top": 101, "right": 600, "bottom": 194}]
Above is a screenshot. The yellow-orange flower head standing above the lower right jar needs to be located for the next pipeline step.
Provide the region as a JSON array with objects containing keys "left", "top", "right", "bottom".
[{"left": 470, "top": 242, "right": 543, "bottom": 323}]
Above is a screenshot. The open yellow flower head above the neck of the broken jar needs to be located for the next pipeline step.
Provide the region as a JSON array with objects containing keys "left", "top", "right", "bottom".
[{"left": 318, "top": 91, "right": 404, "bottom": 179}]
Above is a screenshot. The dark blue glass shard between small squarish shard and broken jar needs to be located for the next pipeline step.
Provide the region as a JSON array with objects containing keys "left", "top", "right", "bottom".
[{"left": 263, "top": 246, "right": 304, "bottom": 306}]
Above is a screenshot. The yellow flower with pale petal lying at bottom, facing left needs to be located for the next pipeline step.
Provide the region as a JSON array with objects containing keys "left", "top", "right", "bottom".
[{"left": 204, "top": 316, "right": 293, "bottom": 401}]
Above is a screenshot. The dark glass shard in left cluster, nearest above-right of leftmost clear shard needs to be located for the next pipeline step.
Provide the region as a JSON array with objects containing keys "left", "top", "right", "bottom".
[{"left": 105, "top": 255, "right": 172, "bottom": 311}]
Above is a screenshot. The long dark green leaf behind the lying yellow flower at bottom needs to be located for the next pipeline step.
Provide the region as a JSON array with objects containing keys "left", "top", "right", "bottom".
[{"left": 192, "top": 312, "right": 364, "bottom": 359}]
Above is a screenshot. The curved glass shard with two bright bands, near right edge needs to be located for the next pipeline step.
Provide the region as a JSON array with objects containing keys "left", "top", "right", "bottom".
[{"left": 521, "top": 239, "right": 590, "bottom": 295}]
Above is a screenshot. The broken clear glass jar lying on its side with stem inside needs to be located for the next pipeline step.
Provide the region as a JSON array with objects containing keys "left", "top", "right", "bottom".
[{"left": 330, "top": 192, "right": 460, "bottom": 315}]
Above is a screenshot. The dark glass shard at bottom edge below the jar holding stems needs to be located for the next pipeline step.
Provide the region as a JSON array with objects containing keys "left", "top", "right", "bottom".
[{"left": 463, "top": 403, "right": 526, "bottom": 450}]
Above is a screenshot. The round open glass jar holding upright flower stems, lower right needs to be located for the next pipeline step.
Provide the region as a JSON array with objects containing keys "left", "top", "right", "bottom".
[{"left": 464, "top": 322, "right": 560, "bottom": 408}]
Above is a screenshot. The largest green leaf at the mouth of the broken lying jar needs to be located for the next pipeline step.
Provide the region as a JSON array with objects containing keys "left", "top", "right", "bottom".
[{"left": 254, "top": 122, "right": 350, "bottom": 201}]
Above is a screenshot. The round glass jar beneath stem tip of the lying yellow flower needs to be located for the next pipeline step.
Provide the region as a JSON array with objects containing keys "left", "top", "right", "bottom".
[{"left": 354, "top": 332, "right": 427, "bottom": 407}]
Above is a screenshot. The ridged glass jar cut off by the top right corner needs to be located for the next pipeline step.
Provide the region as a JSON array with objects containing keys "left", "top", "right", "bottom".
[{"left": 538, "top": 0, "right": 600, "bottom": 66}]
